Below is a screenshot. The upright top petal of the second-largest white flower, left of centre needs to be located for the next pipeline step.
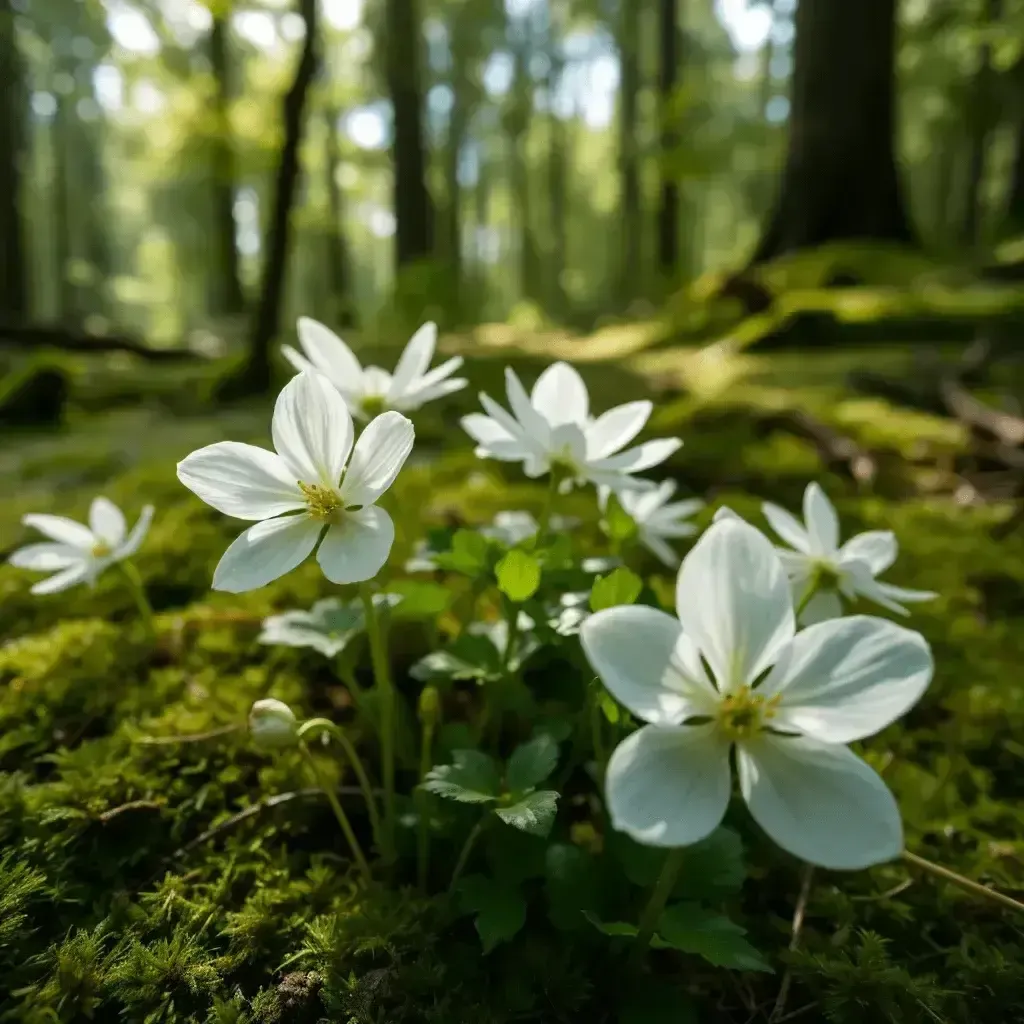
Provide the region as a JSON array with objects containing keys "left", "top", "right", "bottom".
[{"left": 270, "top": 373, "right": 353, "bottom": 487}]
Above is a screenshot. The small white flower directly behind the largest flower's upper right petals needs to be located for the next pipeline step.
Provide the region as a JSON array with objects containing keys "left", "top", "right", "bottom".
[{"left": 762, "top": 483, "right": 936, "bottom": 623}]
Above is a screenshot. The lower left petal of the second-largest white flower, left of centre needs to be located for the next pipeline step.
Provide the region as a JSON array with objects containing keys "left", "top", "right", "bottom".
[{"left": 213, "top": 514, "right": 323, "bottom": 594}]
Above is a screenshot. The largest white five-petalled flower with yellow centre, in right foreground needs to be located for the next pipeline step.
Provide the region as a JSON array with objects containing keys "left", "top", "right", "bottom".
[{"left": 581, "top": 518, "right": 932, "bottom": 869}]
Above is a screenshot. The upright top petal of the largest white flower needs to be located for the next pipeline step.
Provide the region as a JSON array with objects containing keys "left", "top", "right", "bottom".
[{"left": 676, "top": 519, "right": 796, "bottom": 691}]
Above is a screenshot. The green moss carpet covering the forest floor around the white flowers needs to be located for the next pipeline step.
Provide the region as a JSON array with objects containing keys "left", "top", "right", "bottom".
[{"left": 0, "top": 337, "right": 1024, "bottom": 1024}]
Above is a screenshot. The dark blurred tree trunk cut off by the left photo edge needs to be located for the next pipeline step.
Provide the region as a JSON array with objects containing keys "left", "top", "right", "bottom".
[{"left": 0, "top": 0, "right": 30, "bottom": 319}]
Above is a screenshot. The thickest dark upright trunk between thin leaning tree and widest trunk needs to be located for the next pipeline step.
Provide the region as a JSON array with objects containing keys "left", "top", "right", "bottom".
[{"left": 385, "top": 0, "right": 433, "bottom": 269}]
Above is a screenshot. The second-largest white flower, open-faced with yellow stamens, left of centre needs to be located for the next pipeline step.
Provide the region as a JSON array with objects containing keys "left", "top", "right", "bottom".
[{"left": 178, "top": 372, "right": 413, "bottom": 594}]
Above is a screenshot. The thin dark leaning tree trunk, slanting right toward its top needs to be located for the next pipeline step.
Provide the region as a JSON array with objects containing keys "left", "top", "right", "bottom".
[{"left": 237, "top": 0, "right": 317, "bottom": 394}]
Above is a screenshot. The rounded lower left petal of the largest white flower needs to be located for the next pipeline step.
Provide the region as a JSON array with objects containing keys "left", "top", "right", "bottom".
[{"left": 605, "top": 725, "right": 732, "bottom": 847}]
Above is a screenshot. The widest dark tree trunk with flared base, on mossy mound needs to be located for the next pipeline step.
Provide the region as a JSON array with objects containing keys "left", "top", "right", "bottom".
[{"left": 753, "top": 0, "right": 915, "bottom": 263}]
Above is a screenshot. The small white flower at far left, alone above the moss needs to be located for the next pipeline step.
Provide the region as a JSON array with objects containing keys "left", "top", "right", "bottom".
[{"left": 10, "top": 498, "right": 153, "bottom": 594}]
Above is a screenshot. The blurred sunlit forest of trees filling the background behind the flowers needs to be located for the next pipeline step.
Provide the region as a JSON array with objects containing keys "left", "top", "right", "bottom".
[{"left": 6, "top": 0, "right": 1024, "bottom": 382}]
